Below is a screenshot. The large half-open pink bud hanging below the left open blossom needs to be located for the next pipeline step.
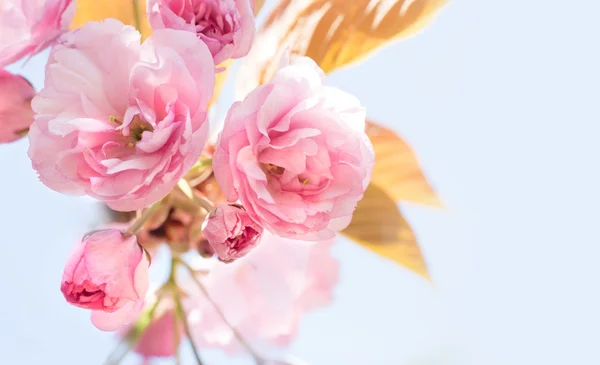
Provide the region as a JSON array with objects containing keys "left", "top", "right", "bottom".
[{"left": 60, "top": 229, "right": 149, "bottom": 331}]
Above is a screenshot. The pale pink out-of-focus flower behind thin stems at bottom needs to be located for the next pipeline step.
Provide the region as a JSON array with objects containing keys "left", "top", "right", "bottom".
[{"left": 186, "top": 232, "right": 338, "bottom": 353}]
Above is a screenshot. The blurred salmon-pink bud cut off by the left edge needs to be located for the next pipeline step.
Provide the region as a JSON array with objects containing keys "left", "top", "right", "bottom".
[{"left": 0, "top": 69, "right": 35, "bottom": 143}]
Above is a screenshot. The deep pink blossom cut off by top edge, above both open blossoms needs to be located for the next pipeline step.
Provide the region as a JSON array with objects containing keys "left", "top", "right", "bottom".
[{"left": 148, "top": 0, "right": 255, "bottom": 64}]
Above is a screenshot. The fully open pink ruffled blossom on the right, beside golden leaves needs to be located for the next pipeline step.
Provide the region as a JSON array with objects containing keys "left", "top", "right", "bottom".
[{"left": 213, "top": 53, "right": 374, "bottom": 241}]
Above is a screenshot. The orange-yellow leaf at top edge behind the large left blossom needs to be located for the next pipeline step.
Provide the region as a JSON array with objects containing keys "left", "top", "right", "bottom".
[{"left": 71, "top": 0, "right": 152, "bottom": 39}]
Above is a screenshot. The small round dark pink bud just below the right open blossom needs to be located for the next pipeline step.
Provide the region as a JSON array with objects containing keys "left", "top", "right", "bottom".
[{"left": 202, "top": 204, "right": 263, "bottom": 262}]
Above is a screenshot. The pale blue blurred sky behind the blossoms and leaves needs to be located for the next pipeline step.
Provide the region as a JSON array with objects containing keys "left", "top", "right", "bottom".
[{"left": 0, "top": 0, "right": 600, "bottom": 365}]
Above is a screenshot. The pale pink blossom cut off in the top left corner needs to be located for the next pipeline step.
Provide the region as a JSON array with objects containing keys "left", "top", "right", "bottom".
[{"left": 0, "top": 0, "right": 75, "bottom": 67}]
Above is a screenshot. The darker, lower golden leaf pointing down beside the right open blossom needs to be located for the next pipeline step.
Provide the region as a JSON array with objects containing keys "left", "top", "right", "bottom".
[{"left": 342, "top": 184, "right": 429, "bottom": 280}]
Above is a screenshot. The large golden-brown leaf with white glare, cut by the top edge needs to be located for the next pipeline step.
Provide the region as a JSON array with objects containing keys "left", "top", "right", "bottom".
[{"left": 239, "top": 0, "right": 447, "bottom": 96}]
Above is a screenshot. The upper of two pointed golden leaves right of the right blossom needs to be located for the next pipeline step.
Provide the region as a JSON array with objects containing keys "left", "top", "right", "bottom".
[{"left": 366, "top": 121, "right": 442, "bottom": 207}]
